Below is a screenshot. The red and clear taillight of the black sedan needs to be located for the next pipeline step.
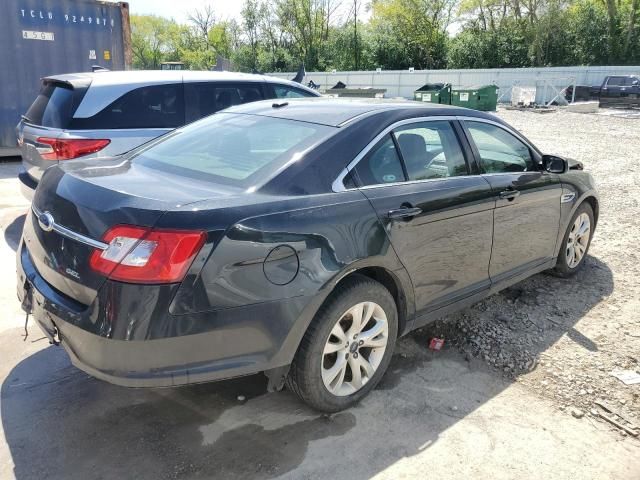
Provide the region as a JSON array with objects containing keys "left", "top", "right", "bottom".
[{"left": 90, "top": 225, "right": 206, "bottom": 283}]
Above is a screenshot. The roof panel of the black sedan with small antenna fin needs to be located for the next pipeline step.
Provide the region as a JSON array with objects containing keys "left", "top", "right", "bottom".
[{"left": 225, "top": 97, "right": 494, "bottom": 127}]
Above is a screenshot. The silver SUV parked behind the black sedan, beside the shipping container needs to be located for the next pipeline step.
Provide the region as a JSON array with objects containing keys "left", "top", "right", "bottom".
[{"left": 17, "top": 70, "right": 319, "bottom": 199}]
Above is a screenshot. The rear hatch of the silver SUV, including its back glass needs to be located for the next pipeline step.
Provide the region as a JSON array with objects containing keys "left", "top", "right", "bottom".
[{"left": 17, "top": 75, "right": 91, "bottom": 181}]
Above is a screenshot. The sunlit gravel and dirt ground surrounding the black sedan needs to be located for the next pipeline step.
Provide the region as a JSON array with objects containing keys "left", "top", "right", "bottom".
[{"left": 0, "top": 110, "right": 640, "bottom": 480}]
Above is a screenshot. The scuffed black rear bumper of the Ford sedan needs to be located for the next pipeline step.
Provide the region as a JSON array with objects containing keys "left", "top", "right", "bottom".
[{"left": 17, "top": 245, "right": 308, "bottom": 387}]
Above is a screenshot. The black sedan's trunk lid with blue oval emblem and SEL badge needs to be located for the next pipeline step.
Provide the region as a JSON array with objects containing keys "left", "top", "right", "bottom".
[{"left": 23, "top": 157, "right": 237, "bottom": 305}]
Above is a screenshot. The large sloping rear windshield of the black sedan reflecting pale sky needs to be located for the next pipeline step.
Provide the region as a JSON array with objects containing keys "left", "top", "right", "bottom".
[{"left": 131, "top": 113, "right": 336, "bottom": 186}]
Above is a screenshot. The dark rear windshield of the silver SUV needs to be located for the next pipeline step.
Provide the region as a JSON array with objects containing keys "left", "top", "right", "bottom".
[{"left": 25, "top": 83, "right": 73, "bottom": 128}]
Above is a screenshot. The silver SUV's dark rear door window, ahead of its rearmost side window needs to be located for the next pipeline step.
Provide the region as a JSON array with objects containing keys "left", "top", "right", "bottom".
[{"left": 184, "top": 82, "right": 264, "bottom": 122}]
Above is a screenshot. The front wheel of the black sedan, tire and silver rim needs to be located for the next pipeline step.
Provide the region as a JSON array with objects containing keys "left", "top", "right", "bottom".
[{"left": 551, "top": 202, "right": 595, "bottom": 278}]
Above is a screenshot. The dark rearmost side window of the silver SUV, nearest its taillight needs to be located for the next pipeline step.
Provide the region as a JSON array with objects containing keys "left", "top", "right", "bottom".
[{"left": 71, "top": 83, "right": 185, "bottom": 130}]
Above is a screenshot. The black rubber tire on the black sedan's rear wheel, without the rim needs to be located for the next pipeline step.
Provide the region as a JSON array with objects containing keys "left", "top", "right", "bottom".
[{"left": 286, "top": 275, "right": 398, "bottom": 413}]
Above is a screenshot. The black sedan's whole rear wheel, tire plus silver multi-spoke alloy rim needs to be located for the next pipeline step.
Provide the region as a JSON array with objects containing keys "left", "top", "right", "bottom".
[{"left": 286, "top": 275, "right": 398, "bottom": 413}]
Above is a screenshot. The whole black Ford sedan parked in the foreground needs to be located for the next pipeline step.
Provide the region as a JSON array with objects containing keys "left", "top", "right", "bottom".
[{"left": 17, "top": 99, "right": 598, "bottom": 411}]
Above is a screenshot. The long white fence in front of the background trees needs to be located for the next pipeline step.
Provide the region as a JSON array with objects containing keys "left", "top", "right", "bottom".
[{"left": 271, "top": 66, "right": 640, "bottom": 103}]
